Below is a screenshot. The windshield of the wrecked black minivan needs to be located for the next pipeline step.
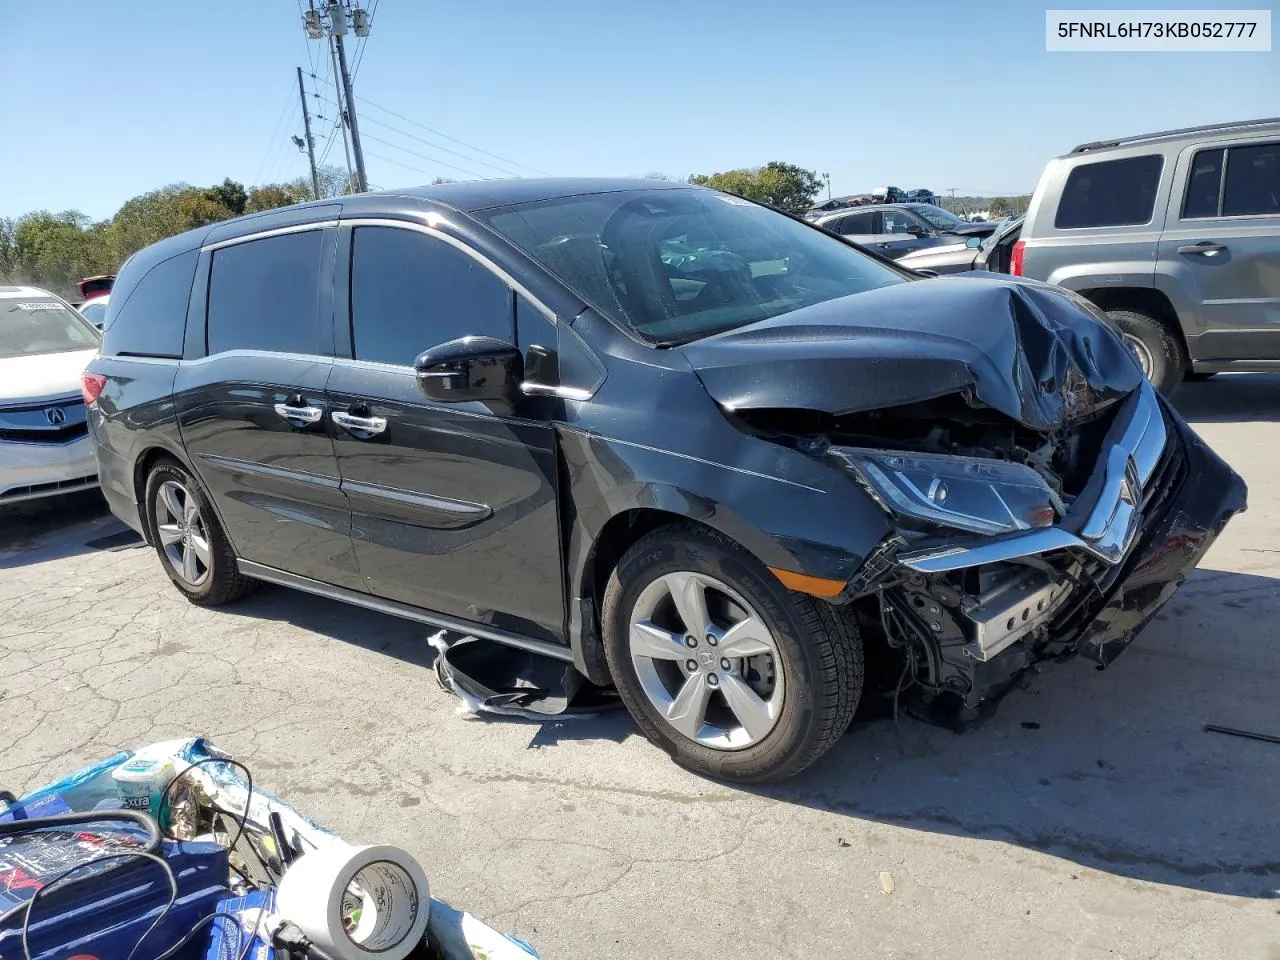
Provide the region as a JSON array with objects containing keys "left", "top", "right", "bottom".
[{"left": 476, "top": 189, "right": 904, "bottom": 346}]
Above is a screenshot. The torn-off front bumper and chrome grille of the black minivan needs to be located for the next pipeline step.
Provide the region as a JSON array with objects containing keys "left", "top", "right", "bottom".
[{"left": 865, "top": 384, "right": 1247, "bottom": 707}]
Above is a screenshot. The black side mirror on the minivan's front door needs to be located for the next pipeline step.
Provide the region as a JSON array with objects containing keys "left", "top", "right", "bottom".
[{"left": 413, "top": 337, "right": 525, "bottom": 406}]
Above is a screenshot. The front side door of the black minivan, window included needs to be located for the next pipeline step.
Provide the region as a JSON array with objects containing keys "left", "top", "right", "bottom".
[{"left": 329, "top": 224, "right": 564, "bottom": 643}]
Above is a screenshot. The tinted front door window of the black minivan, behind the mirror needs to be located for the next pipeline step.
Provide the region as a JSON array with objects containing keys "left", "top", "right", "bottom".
[{"left": 351, "top": 227, "right": 513, "bottom": 366}]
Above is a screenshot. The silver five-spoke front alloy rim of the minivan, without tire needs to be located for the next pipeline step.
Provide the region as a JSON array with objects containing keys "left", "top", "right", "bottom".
[{"left": 628, "top": 571, "right": 786, "bottom": 750}]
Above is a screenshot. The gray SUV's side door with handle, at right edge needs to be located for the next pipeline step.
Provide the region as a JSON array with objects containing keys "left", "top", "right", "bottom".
[{"left": 1158, "top": 142, "right": 1280, "bottom": 360}]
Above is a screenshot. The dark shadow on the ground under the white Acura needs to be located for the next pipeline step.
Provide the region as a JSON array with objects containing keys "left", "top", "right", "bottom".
[{"left": 0, "top": 490, "right": 142, "bottom": 570}]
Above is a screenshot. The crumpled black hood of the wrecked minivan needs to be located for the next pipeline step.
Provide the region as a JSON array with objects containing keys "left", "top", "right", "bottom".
[{"left": 681, "top": 274, "right": 1142, "bottom": 430}]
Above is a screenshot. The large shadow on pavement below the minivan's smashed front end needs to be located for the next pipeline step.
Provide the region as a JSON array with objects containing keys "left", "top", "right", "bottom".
[{"left": 764, "top": 571, "right": 1280, "bottom": 897}]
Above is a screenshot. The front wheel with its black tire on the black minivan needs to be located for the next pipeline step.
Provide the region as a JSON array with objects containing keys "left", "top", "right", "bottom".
[{"left": 602, "top": 524, "right": 864, "bottom": 783}]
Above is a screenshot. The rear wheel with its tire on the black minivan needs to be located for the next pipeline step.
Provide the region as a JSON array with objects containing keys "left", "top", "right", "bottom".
[{"left": 145, "top": 461, "right": 256, "bottom": 607}]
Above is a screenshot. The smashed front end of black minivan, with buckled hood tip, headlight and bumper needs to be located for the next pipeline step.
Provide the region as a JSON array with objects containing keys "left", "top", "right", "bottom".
[{"left": 691, "top": 282, "right": 1245, "bottom": 722}]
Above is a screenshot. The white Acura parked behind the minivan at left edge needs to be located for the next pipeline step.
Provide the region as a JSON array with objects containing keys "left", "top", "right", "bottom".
[{"left": 0, "top": 287, "right": 101, "bottom": 506}]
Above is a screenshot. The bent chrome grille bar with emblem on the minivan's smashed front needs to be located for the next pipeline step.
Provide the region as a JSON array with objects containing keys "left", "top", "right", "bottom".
[{"left": 899, "top": 381, "right": 1169, "bottom": 573}]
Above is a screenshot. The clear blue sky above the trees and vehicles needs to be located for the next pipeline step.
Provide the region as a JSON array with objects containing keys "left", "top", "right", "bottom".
[{"left": 0, "top": 0, "right": 1280, "bottom": 218}]
